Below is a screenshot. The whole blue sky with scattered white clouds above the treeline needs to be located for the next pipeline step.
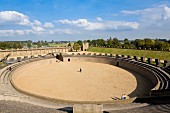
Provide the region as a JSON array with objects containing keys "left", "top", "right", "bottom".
[{"left": 0, "top": 0, "right": 170, "bottom": 41}]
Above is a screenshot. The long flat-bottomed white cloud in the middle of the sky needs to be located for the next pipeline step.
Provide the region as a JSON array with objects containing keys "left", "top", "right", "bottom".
[{"left": 57, "top": 19, "right": 139, "bottom": 30}]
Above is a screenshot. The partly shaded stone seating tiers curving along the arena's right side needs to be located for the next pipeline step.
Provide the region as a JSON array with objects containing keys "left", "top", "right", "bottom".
[{"left": 65, "top": 53, "right": 170, "bottom": 96}]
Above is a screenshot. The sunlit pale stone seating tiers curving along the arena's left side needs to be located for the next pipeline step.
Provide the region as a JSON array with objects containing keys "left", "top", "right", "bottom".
[{"left": 0, "top": 58, "right": 72, "bottom": 109}]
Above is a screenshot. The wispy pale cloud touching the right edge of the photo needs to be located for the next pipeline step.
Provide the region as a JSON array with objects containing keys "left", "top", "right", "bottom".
[{"left": 121, "top": 5, "right": 170, "bottom": 27}]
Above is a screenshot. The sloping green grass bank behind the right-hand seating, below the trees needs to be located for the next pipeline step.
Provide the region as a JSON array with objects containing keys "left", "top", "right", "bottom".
[{"left": 88, "top": 47, "right": 170, "bottom": 60}]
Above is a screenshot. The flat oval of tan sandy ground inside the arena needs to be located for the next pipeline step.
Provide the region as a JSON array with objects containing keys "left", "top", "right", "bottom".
[{"left": 13, "top": 59, "right": 150, "bottom": 101}]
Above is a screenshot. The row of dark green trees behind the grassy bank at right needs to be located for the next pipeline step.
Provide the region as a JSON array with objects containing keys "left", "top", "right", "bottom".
[{"left": 76, "top": 37, "right": 170, "bottom": 50}]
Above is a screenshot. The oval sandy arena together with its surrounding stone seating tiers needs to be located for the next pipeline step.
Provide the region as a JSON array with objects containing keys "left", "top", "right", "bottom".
[{"left": 0, "top": 53, "right": 169, "bottom": 111}]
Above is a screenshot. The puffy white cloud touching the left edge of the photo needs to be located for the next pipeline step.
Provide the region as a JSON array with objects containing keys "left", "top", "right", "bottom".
[{"left": 0, "top": 11, "right": 31, "bottom": 26}]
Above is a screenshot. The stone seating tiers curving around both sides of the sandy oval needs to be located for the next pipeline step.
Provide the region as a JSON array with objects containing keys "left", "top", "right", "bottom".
[{"left": 0, "top": 53, "right": 170, "bottom": 111}]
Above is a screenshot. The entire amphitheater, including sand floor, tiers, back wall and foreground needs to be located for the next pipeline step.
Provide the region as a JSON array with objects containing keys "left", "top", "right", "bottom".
[{"left": 0, "top": 47, "right": 170, "bottom": 113}]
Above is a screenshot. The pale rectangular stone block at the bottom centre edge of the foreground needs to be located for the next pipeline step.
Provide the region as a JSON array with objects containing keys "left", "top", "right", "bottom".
[{"left": 73, "top": 104, "right": 103, "bottom": 113}]
